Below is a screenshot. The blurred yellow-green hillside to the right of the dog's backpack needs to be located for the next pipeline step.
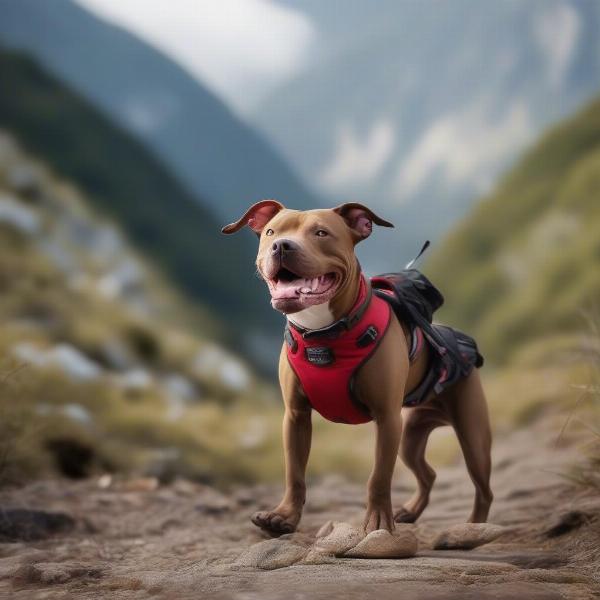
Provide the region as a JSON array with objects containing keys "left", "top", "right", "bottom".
[{"left": 426, "top": 100, "right": 600, "bottom": 363}]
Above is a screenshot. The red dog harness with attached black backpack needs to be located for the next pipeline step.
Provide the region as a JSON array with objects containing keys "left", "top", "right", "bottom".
[{"left": 285, "top": 243, "right": 483, "bottom": 424}]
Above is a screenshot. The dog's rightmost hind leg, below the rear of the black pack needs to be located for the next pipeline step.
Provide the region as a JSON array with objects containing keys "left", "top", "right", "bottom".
[{"left": 449, "top": 369, "right": 494, "bottom": 523}]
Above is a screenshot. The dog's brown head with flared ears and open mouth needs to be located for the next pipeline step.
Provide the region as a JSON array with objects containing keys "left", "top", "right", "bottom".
[{"left": 222, "top": 200, "right": 393, "bottom": 314}]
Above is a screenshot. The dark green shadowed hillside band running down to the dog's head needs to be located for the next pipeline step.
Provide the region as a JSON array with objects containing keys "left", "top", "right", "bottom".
[{"left": 0, "top": 51, "right": 273, "bottom": 342}]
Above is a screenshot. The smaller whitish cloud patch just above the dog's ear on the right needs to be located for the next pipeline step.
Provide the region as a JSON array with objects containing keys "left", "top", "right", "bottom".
[{"left": 319, "top": 119, "right": 396, "bottom": 191}]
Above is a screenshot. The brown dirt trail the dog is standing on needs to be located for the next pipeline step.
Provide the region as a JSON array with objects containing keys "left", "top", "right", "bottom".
[{"left": 0, "top": 425, "right": 600, "bottom": 600}]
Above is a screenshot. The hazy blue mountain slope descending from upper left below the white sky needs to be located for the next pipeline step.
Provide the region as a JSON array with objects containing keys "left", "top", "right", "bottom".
[{"left": 0, "top": 0, "right": 317, "bottom": 220}]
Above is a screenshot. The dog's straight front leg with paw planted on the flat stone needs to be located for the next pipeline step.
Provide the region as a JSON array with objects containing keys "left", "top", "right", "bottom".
[{"left": 363, "top": 406, "right": 402, "bottom": 533}]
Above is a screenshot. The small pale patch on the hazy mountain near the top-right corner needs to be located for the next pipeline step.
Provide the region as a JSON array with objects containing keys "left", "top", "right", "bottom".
[{"left": 534, "top": 4, "right": 581, "bottom": 88}]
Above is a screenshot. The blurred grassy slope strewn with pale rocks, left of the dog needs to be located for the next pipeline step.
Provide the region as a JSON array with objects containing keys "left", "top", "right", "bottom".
[{"left": 0, "top": 125, "right": 268, "bottom": 488}]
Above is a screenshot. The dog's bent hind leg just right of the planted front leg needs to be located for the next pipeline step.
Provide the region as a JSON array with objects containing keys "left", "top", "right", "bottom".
[{"left": 394, "top": 408, "right": 440, "bottom": 523}]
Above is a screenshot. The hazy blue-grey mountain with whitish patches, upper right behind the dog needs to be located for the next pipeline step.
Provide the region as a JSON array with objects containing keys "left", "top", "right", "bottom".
[{"left": 253, "top": 0, "right": 600, "bottom": 269}]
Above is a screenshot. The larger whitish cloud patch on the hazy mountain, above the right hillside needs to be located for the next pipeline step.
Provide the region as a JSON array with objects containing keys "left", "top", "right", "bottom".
[{"left": 394, "top": 102, "right": 533, "bottom": 201}]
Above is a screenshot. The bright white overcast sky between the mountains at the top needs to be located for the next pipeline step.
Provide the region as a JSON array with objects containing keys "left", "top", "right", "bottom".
[{"left": 76, "top": 0, "right": 315, "bottom": 114}]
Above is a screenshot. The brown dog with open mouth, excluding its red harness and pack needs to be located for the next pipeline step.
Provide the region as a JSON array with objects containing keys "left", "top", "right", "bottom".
[{"left": 223, "top": 200, "right": 492, "bottom": 535}]
